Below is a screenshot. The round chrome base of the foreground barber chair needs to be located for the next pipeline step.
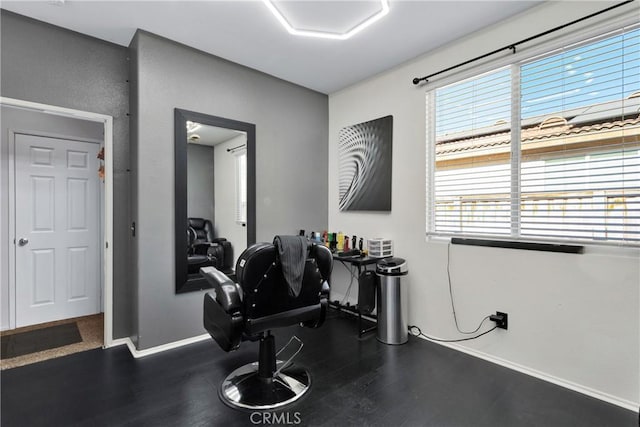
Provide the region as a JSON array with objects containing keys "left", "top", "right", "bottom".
[{"left": 219, "top": 360, "right": 311, "bottom": 410}]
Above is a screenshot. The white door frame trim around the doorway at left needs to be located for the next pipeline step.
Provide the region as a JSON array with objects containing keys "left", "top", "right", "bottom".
[{"left": 0, "top": 97, "right": 113, "bottom": 348}]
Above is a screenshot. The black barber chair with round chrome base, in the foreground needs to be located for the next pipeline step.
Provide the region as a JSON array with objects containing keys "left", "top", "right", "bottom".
[{"left": 201, "top": 241, "right": 333, "bottom": 410}]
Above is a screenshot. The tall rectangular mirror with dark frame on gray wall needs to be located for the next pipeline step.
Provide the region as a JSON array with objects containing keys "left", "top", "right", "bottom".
[{"left": 175, "top": 108, "right": 256, "bottom": 293}]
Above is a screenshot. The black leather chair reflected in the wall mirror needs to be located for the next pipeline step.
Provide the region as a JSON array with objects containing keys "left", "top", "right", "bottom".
[{"left": 187, "top": 218, "right": 233, "bottom": 274}]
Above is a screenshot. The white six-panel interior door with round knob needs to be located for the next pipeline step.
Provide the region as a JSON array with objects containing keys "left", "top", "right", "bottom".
[{"left": 14, "top": 134, "right": 101, "bottom": 327}]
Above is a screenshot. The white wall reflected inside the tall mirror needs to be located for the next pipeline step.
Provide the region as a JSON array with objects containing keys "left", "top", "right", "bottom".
[{"left": 214, "top": 134, "right": 247, "bottom": 268}]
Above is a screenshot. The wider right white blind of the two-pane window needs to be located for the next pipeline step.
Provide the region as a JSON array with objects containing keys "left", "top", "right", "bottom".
[{"left": 521, "top": 30, "right": 640, "bottom": 242}]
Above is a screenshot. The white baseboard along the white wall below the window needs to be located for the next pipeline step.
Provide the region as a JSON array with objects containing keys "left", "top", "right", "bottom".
[{"left": 412, "top": 337, "right": 640, "bottom": 412}]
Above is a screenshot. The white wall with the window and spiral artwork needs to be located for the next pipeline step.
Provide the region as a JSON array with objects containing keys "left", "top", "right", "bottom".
[{"left": 328, "top": 2, "right": 640, "bottom": 410}]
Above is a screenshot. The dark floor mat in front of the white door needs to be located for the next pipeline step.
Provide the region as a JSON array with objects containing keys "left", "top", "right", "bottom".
[{"left": 0, "top": 322, "right": 82, "bottom": 359}]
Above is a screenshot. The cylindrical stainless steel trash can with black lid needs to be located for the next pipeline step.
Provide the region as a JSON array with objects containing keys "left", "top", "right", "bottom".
[{"left": 376, "top": 258, "right": 409, "bottom": 345}]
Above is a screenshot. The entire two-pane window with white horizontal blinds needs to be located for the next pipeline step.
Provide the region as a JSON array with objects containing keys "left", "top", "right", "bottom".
[{"left": 427, "top": 28, "right": 640, "bottom": 245}]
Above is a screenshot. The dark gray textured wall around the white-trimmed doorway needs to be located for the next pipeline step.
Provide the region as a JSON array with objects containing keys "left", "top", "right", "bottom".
[{"left": 0, "top": 10, "right": 133, "bottom": 338}]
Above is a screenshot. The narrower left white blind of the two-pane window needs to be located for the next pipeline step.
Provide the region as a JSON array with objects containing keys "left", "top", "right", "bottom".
[{"left": 431, "top": 68, "right": 511, "bottom": 239}]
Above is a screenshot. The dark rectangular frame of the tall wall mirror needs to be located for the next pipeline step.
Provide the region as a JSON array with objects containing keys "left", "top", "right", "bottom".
[{"left": 174, "top": 108, "right": 256, "bottom": 294}]
